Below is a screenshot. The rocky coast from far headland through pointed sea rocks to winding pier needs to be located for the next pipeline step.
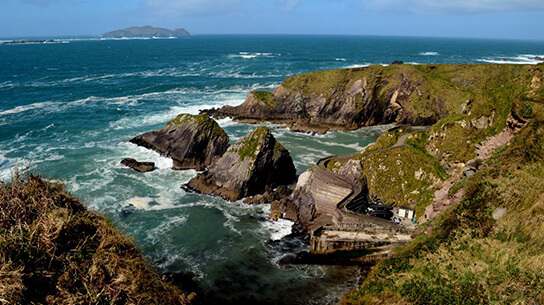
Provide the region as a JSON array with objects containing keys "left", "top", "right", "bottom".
[{"left": 127, "top": 64, "right": 542, "bottom": 264}]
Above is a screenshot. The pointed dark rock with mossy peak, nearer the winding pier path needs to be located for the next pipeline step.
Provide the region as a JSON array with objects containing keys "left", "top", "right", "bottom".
[{"left": 187, "top": 127, "right": 296, "bottom": 201}]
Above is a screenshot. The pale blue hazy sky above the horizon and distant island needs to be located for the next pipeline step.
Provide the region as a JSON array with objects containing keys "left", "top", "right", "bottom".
[{"left": 0, "top": 0, "right": 544, "bottom": 40}]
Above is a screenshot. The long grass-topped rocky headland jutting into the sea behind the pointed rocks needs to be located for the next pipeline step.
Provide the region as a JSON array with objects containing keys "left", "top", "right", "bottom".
[{"left": 208, "top": 64, "right": 541, "bottom": 132}]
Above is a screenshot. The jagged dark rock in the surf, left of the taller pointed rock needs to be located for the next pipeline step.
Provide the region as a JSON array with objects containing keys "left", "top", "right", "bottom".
[{"left": 130, "top": 114, "right": 229, "bottom": 170}]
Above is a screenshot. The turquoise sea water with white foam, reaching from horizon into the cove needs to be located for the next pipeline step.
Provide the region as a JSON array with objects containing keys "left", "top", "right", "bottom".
[{"left": 0, "top": 36, "right": 544, "bottom": 304}]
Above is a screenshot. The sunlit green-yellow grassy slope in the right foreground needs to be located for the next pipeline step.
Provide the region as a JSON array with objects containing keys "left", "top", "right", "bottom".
[{"left": 343, "top": 119, "right": 544, "bottom": 304}]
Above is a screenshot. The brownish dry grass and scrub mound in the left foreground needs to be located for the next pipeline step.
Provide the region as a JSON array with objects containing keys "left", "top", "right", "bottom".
[{"left": 0, "top": 173, "right": 186, "bottom": 304}]
